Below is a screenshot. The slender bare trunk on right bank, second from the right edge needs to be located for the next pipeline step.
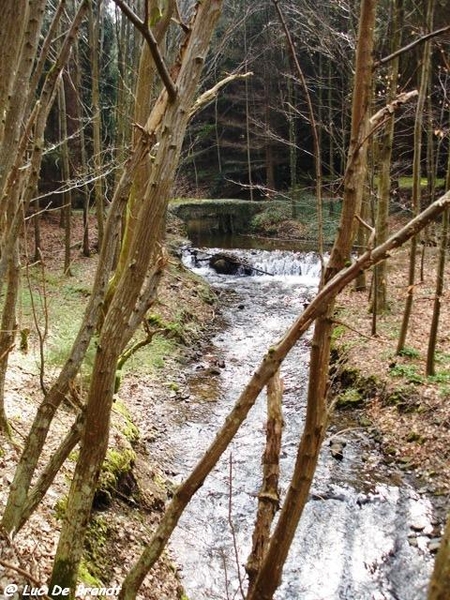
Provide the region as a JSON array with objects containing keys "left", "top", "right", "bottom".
[{"left": 397, "top": 0, "right": 434, "bottom": 354}]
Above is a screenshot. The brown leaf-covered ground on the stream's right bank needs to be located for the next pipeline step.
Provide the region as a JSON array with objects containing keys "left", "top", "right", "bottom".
[{"left": 333, "top": 216, "right": 450, "bottom": 516}]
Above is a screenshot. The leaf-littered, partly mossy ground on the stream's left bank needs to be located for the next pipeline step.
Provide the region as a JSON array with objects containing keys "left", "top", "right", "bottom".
[{"left": 0, "top": 216, "right": 215, "bottom": 600}]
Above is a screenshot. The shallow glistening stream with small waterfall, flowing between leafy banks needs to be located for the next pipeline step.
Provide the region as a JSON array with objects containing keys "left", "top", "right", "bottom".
[{"left": 153, "top": 249, "right": 433, "bottom": 600}]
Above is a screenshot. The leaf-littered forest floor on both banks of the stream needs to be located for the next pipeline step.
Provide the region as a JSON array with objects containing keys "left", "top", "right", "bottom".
[{"left": 0, "top": 213, "right": 450, "bottom": 600}]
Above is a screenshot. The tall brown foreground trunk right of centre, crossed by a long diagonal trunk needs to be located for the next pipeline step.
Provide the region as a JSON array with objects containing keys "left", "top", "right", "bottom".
[{"left": 247, "top": 0, "right": 377, "bottom": 600}]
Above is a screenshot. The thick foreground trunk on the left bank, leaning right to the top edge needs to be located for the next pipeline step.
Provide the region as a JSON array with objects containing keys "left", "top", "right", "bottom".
[{"left": 51, "top": 0, "right": 221, "bottom": 597}]
